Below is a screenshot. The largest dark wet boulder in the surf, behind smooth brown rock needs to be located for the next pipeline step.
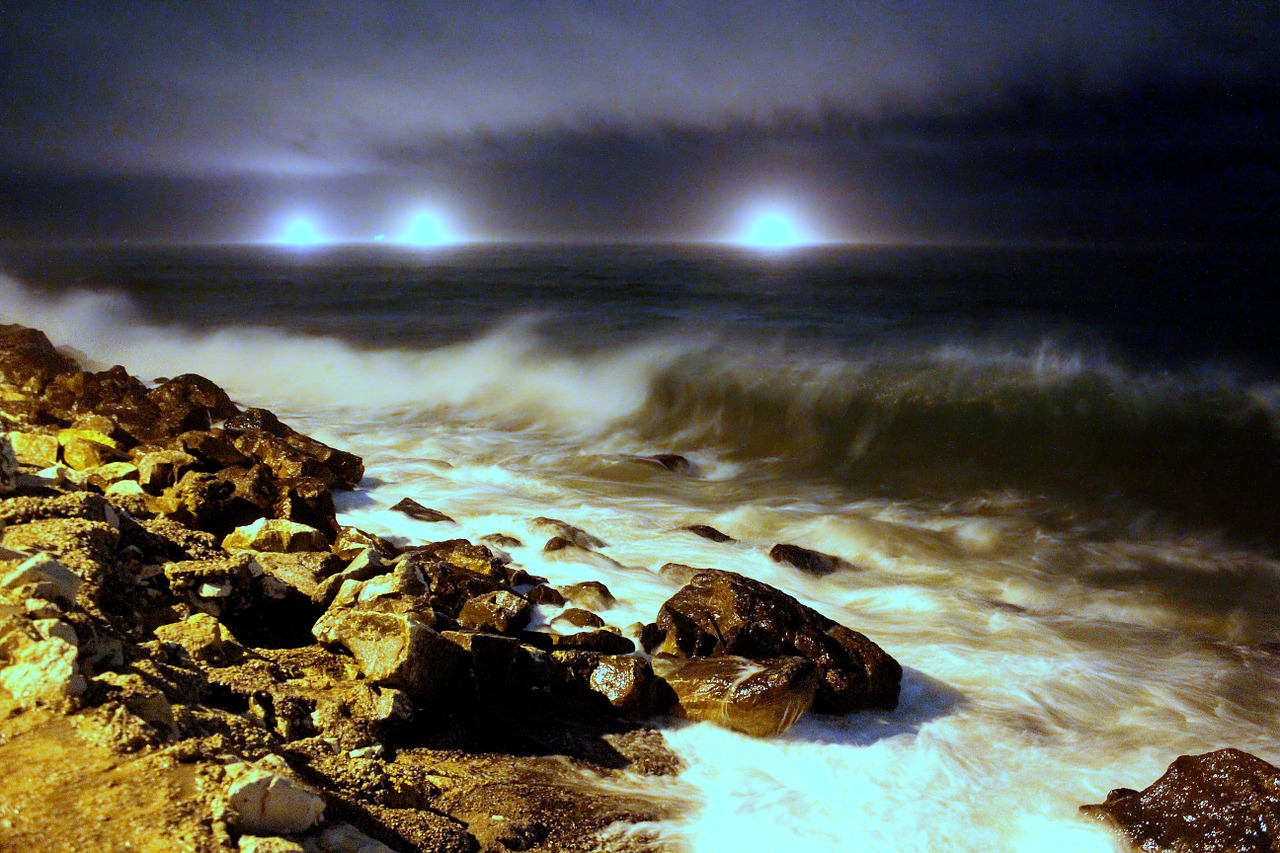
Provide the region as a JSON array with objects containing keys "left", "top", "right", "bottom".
[{"left": 645, "top": 569, "right": 902, "bottom": 713}]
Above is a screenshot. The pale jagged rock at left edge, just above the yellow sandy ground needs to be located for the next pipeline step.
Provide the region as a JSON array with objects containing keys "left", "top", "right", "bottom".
[{"left": 0, "top": 615, "right": 87, "bottom": 707}]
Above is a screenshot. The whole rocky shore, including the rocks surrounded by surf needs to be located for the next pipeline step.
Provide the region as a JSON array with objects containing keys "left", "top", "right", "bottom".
[{"left": 0, "top": 325, "right": 1280, "bottom": 853}]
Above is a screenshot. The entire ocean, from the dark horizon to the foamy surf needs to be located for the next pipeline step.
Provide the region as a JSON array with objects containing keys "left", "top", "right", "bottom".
[{"left": 0, "top": 245, "right": 1280, "bottom": 853}]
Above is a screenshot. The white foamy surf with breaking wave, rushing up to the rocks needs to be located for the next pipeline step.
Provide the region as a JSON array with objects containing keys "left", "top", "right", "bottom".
[{"left": 0, "top": 251, "right": 1280, "bottom": 853}]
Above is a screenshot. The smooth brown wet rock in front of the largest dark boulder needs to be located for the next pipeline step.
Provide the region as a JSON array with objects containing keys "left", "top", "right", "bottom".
[{"left": 659, "top": 654, "right": 818, "bottom": 738}]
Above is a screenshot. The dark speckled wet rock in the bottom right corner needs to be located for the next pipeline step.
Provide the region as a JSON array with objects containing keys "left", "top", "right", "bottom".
[{"left": 1080, "top": 749, "right": 1280, "bottom": 853}]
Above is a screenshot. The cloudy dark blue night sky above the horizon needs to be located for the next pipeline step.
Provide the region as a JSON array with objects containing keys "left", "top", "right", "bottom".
[{"left": 0, "top": 0, "right": 1280, "bottom": 242}]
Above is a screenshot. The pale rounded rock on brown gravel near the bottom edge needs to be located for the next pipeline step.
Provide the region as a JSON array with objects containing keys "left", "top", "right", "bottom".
[{"left": 227, "top": 756, "right": 325, "bottom": 835}]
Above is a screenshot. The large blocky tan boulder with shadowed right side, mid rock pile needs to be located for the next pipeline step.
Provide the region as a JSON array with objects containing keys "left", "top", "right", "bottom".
[{"left": 312, "top": 607, "right": 465, "bottom": 702}]
